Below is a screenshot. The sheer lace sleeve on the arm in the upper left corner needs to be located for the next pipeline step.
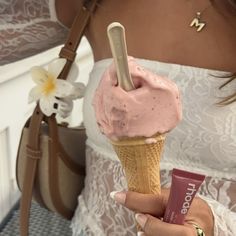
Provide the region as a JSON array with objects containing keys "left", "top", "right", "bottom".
[{"left": 0, "top": 0, "right": 67, "bottom": 65}]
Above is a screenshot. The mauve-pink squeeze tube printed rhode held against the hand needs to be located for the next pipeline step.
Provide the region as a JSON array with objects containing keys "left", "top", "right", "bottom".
[{"left": 163, "top": 169, "right": 205, "bottom": 225}]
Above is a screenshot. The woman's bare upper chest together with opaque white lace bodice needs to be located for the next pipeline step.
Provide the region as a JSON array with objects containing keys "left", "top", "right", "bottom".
[{"left": 81, "top": 0, "right": 236, "bottom": 175}]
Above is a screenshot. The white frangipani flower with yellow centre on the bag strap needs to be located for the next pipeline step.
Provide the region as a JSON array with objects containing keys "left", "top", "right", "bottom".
[{"left": 29, "top": 58, "right": 84, "bottom": 117}]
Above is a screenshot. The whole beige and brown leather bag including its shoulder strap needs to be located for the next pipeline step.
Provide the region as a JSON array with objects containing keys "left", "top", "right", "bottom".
[{"left": 16, "top": 0, "right": 97, "bottom": 236}]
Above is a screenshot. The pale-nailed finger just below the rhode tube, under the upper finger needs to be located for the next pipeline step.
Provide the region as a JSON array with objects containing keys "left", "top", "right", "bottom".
[{"left": 135, "top": 213, "right": 196, "bottom": 236}]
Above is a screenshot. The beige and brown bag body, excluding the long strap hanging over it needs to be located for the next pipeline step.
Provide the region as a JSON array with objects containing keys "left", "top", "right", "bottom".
[{"left": 16, "top": 120, "right": 86, "bottom": 216}]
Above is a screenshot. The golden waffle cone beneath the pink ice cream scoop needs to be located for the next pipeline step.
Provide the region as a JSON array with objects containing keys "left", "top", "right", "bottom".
[{"left": 112, "top": 134, "right": 165, "bottom": 194}]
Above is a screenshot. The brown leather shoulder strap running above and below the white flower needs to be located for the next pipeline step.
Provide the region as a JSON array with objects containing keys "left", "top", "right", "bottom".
[{"left": 20, "top": 0, "right": 98, "bottom": 236}]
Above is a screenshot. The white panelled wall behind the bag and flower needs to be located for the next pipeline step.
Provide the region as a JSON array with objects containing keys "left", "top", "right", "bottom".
[{"left": 0, "top": 39, "right": 93, "bottom": 222}]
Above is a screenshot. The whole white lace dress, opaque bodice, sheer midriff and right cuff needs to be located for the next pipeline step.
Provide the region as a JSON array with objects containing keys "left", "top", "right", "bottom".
[{"left": 72, "top": 59, "right": 236, "bottom": 236}]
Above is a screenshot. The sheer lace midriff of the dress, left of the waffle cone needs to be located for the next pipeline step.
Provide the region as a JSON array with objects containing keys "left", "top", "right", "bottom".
[{"left": 72, "top": 148, "right": 136, "bottom": 236}]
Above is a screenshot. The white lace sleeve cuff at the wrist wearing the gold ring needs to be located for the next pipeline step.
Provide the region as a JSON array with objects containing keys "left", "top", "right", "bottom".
[{"left": 199, "top": 196, "right": 236, "bottom": 236}]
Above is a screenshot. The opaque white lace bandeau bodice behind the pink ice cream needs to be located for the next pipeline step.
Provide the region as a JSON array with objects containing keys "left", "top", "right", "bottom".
[{"left": 84, "top": 59, "right": 236, "bottom": 179}]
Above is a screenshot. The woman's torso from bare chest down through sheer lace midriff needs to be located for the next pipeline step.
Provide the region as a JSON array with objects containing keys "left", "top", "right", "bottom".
[{"left": 74, "top": 0, "right": 236, "bottom": 235}]
